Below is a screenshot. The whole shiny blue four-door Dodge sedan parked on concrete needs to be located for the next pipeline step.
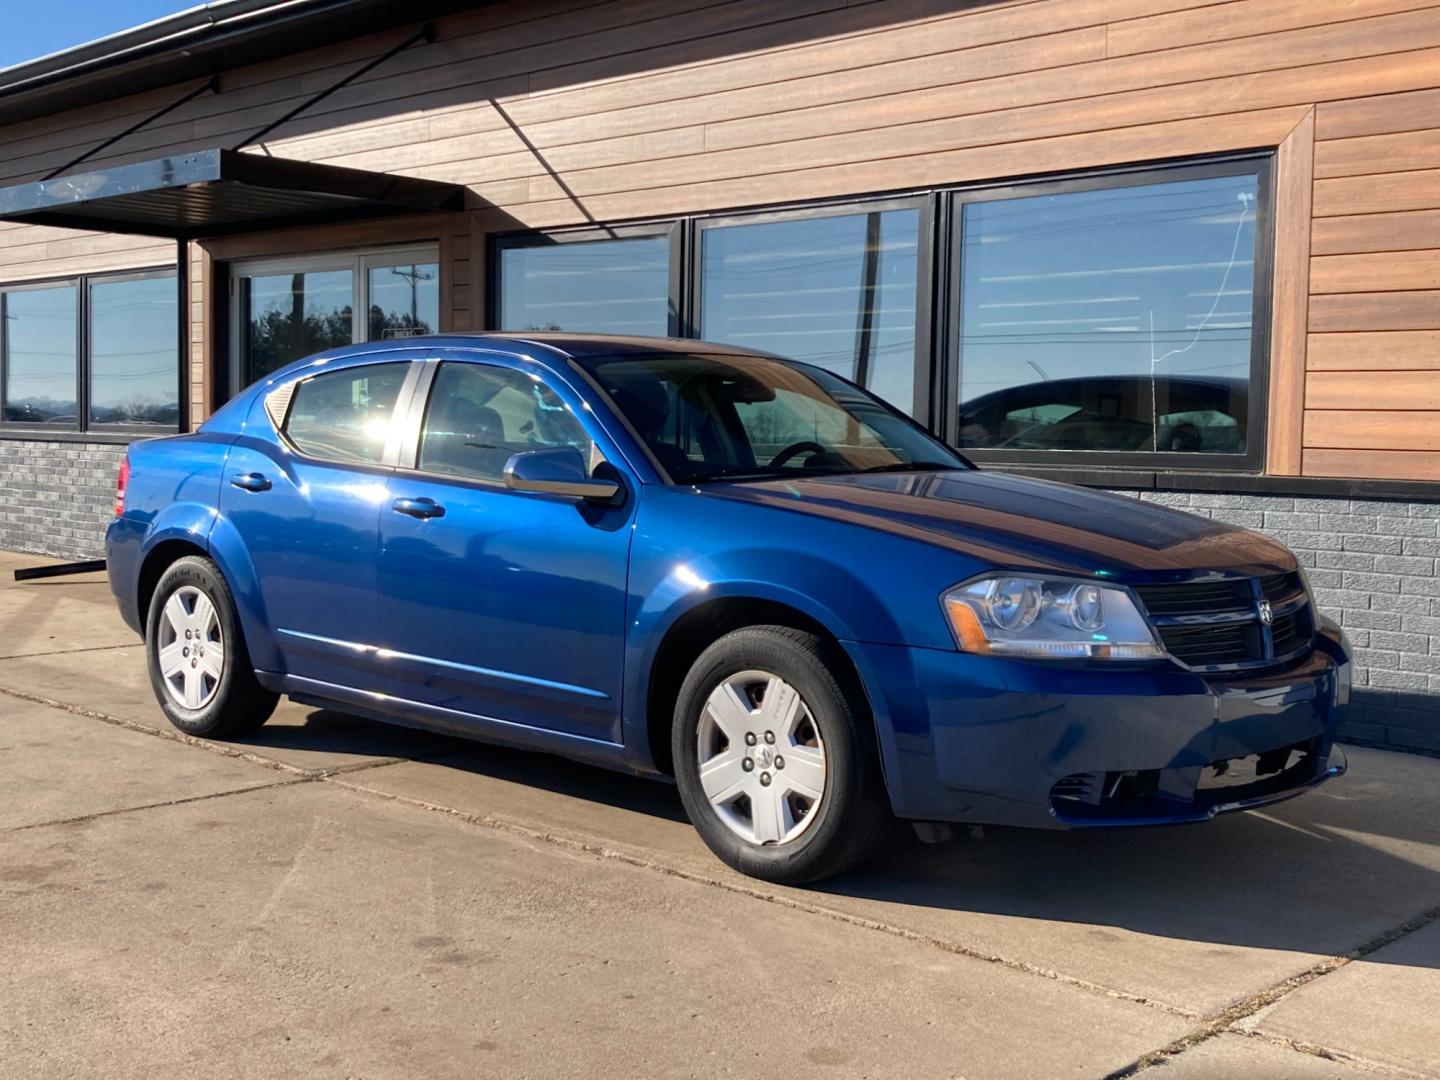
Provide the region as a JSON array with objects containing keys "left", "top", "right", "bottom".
[{"left": 107, "top": 334, "right": 1351, "bottom": 883}]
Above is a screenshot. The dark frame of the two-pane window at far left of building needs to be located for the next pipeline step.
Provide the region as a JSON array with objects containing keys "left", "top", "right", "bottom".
[{"left": 0, "top": 265, "right": 180, "bottom": 439}]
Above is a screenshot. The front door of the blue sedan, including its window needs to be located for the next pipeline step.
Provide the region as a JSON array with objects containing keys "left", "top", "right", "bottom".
[{"left": 380, "top": 359, "right": 636, "bottom": 743}]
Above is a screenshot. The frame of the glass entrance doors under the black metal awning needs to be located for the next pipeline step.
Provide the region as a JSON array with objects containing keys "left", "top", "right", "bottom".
[{"left": 226, "top": 242, "right": 445, "bottom": 397}]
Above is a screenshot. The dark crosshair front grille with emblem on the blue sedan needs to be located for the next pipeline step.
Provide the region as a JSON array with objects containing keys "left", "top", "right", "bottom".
[{"left": 1135, "top": 572, "right": 1315, "bottom": 668}]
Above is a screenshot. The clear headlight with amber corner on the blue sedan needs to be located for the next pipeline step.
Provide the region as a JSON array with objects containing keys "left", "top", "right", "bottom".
[{"left": 943, "top": 575, "right": 1165, "bottom": 660}]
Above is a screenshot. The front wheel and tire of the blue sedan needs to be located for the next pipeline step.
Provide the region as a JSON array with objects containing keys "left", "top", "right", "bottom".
[{"left": 671, "top": 626, "right": 894, "bottom": 884}]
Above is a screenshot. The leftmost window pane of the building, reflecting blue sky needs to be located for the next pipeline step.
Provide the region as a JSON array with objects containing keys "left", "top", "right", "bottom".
[{"left": 3, "top": 285, "right": 79, "bottom": 426}]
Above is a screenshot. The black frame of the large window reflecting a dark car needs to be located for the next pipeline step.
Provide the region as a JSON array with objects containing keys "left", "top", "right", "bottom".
[{"left": 932, "top": 153, "right": 1274, "bottom": 472}]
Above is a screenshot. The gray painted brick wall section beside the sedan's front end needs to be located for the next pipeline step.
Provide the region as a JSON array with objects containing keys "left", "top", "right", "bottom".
[{"left": 1117, "top": 491, "right": 1440, "bottom": 755}]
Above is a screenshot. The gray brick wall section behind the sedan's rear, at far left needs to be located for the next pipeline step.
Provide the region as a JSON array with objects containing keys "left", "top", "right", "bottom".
[{"left": 0, "top": 439, "right": 125, "bottom": 559}]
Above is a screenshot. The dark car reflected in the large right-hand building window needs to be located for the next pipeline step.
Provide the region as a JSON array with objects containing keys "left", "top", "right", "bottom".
[{"left": 960, "top": 376, "right": 1248, "bottom": 454}]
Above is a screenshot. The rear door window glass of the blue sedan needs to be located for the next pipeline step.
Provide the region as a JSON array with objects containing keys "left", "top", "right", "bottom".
[{"left": 285, "top": 363, "right": 410, "bottom": 465}]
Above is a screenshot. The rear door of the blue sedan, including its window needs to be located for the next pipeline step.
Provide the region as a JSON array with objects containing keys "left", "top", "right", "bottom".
[{"left": 220, "top": 354, "right": 420, "bottom": 690}]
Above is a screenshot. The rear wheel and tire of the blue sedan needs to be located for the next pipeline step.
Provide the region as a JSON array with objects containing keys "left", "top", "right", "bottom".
[{"left": 145, "top": 556, "right": 279, "bottom": 739}]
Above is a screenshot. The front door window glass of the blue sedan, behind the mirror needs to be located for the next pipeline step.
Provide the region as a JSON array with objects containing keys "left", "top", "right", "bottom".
[{"left": 419, "top": 363, "right": 598, "bottom": 482}]
